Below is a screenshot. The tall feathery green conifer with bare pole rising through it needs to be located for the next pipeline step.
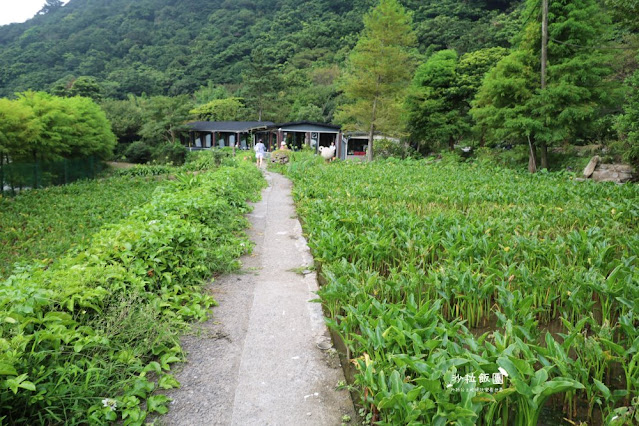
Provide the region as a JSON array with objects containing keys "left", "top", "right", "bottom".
[{"left": 472, "top": 0, "right": 611, "bottom": 172}]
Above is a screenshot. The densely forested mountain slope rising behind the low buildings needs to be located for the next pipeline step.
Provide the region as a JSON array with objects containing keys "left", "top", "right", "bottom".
[{"left": 0, "top": 0, "right": 520, "bottom": 98}]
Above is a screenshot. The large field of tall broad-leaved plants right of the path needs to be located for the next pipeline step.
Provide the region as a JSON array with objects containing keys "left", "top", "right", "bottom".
[{"left": 288, "top": 160, "right": 639, "bottom": 426}]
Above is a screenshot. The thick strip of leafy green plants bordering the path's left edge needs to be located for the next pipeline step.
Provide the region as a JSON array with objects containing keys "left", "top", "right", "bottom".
[{"left": 0, "top": 159, "right": 265, "bottom": 425}]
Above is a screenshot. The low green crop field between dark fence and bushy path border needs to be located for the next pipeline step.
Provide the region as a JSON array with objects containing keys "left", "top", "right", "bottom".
[{"left": 0, "top": 177, "right": 164, "bottom": 279}]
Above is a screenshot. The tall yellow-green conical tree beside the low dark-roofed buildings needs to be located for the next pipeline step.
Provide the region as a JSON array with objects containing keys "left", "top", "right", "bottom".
[{"left": 336, "top": 0, "right": 417, "bottom": 161}]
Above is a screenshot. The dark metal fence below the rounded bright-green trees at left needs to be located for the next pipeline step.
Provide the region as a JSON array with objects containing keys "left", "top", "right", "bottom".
[{"left": 0, "top": 157, "right": 105, "bottom": 194}]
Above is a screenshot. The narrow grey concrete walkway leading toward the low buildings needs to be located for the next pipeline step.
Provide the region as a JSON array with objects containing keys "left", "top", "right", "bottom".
[{"left": 160, "top": 172, "right": 355, "bottom": 426}]
